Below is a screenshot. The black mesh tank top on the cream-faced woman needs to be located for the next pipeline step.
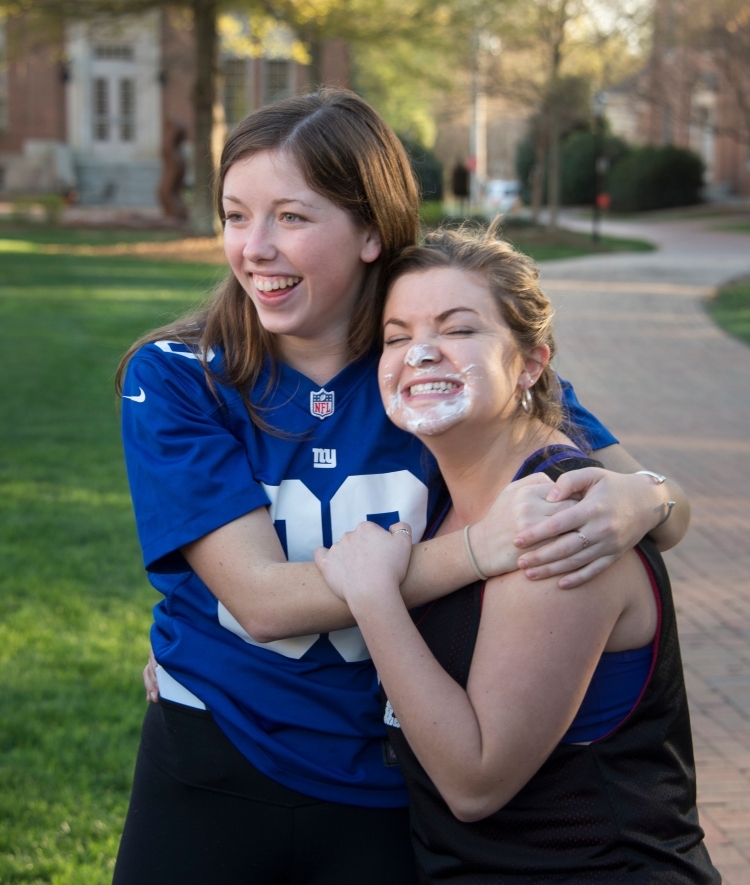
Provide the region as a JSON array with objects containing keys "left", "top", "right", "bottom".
[{"left": 383, "top": 447, "right": 721, "bottom": 885}]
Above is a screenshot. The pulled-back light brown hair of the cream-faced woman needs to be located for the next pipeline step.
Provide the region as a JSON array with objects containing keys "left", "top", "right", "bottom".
[{"left": 387, "top": 217, "right": 563, "bottom": 428}]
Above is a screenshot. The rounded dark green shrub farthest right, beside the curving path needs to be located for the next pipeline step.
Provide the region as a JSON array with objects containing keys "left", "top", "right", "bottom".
[{"left": 607, "top": 145, "right": 703, "bottom": 212}]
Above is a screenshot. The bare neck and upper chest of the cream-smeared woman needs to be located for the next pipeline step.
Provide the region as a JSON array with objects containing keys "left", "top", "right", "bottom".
[{"left": 422, "top": 417, "right": 570, "bottom": 526}]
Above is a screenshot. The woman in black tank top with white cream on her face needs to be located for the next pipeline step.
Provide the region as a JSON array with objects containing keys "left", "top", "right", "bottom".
[{"left": 315, "top": 229, "right": 721, "bottom": 885}]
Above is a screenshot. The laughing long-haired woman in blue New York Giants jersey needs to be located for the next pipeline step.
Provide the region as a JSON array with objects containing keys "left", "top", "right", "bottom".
[{"left": 120, "top": 90, "right": 687, "bottom": 885}]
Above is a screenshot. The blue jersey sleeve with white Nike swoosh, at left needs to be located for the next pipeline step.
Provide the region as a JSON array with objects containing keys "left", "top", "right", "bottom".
[{"left": 122, "top": 352, "right": 269, "bottom": 572}]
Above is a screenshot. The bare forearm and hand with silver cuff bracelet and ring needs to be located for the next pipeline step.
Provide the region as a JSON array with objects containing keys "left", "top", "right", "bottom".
[{"left": 516, "top": 445, "right": 690, "bottom": 588}]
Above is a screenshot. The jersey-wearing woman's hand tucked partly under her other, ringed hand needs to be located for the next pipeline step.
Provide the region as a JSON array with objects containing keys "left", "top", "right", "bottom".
[{"left": 471, "top": 473, "right": 576, "bottom": 575}]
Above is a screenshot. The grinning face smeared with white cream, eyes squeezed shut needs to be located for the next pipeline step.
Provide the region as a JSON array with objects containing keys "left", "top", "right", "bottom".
[{"left": 379, "top": 267, "right": 541, "bottom": 437}]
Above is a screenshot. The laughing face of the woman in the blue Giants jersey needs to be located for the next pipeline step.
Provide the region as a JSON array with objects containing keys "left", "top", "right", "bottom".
[{"left": 223, "top": 151, "right": 380, "bottom": 357}]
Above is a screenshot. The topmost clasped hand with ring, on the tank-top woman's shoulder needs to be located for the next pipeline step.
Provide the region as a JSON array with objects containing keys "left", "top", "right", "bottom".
[{"left": 514, "top": 467, "right": 666, "bottom": 588}]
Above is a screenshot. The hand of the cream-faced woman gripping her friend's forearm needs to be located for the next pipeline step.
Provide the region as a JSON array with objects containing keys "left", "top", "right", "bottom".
[{"left": 315, "top": 522, "right": 412, "bottom": 607}]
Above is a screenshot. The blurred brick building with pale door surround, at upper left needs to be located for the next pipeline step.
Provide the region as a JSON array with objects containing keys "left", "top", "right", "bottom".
[{"left": 0, "top": 7, "right": 350, "bottom": 208}]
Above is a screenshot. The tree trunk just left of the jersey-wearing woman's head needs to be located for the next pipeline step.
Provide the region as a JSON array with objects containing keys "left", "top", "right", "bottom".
[{"left": 190, "top": 0, "right": 219, "bottom": 236}]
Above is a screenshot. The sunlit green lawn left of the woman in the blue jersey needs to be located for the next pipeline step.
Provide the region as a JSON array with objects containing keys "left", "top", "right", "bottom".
[{"left": 0, "top": 237, "right": 223, "bottom": 885}]
